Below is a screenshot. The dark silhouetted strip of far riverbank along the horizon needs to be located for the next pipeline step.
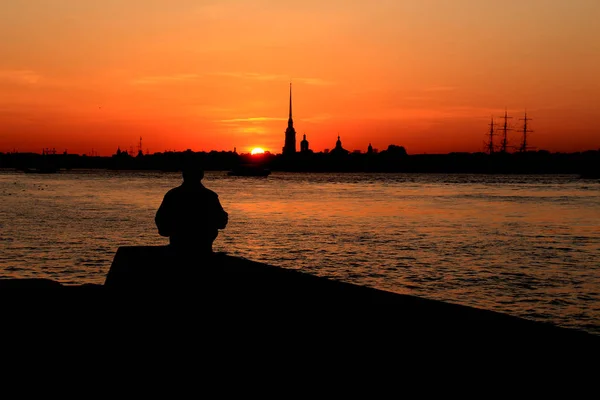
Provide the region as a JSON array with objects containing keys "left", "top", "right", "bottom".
[{"left": 0, "top": 145, "right": 600, "bottom": 176}]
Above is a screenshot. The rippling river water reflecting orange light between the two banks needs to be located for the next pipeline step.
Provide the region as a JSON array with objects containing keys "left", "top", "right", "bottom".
[{"left": 0, "top": 170, "right": 600, "bottom": 334}]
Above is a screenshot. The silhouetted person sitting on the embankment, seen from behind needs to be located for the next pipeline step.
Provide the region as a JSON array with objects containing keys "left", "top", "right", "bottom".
[{"left": 154, "top": 162, "right": 228, "bottom": 255}]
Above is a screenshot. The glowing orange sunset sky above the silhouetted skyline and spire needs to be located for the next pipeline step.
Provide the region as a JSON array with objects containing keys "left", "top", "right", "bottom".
[{"left": 0, "top": 0, "right": 600, "bottom": 155}]
